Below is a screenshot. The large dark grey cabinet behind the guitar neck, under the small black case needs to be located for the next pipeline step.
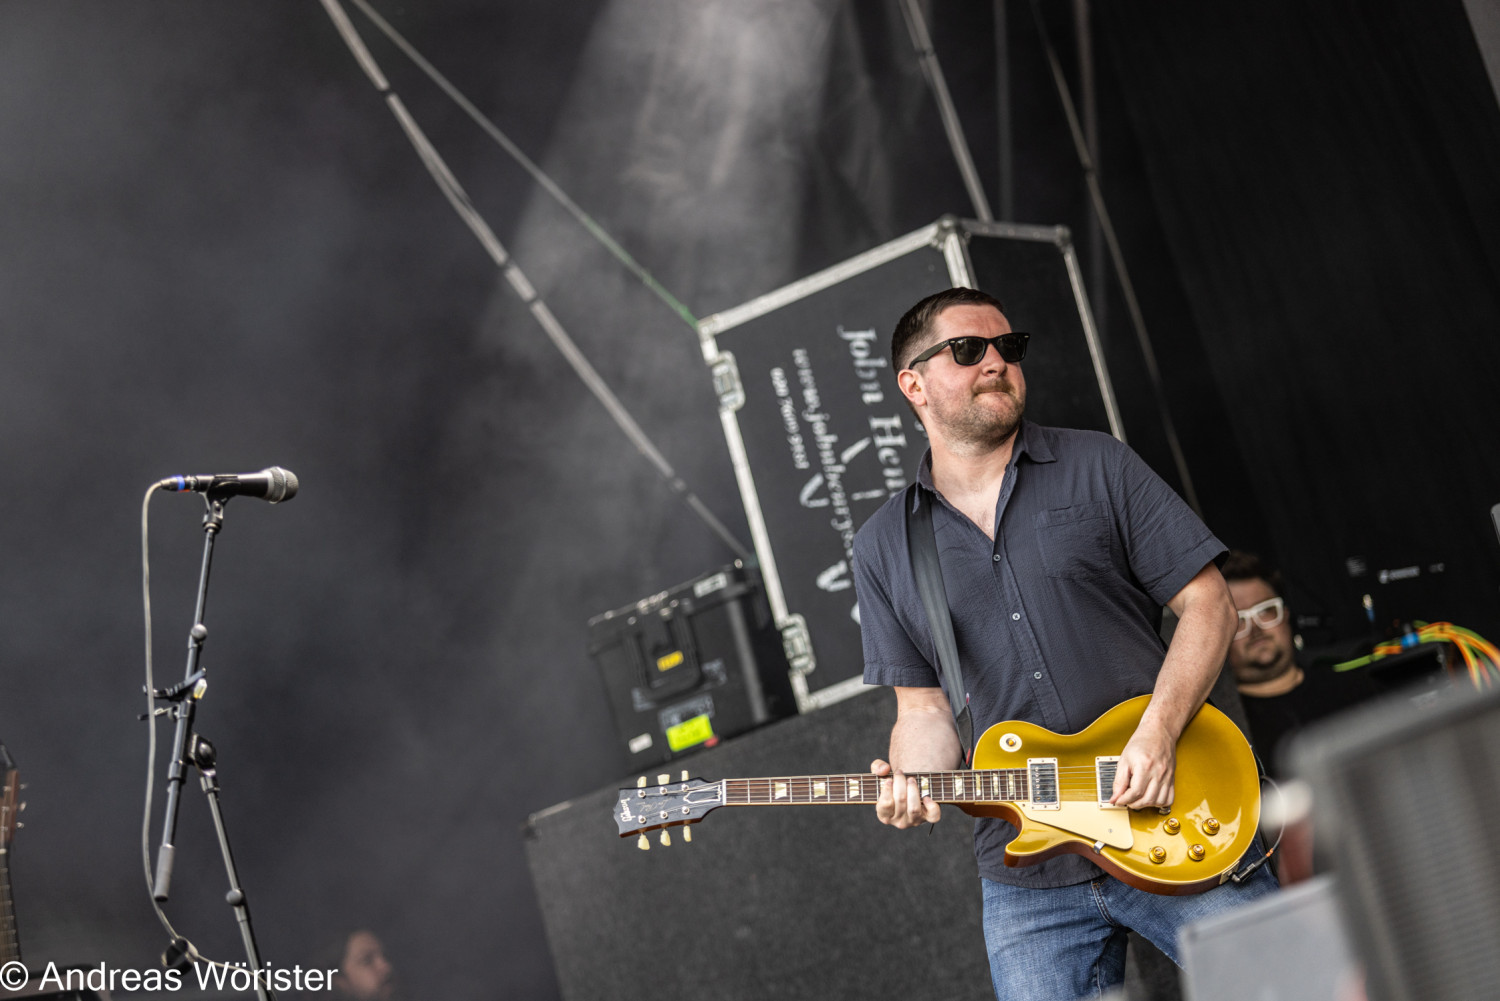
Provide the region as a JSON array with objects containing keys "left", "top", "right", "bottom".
[{"left": 527, "top": 689, "right": 992, "bottom": 1001}]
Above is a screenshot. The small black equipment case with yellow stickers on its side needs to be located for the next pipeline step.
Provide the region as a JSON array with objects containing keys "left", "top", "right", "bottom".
[{"left": 588, "top": 561, "right": 795, "bottom": 771}]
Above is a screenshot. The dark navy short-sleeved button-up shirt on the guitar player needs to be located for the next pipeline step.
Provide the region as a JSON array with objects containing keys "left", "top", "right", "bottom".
[{"left": 854, "top": 422, "right": 1224, "bottom": 887}]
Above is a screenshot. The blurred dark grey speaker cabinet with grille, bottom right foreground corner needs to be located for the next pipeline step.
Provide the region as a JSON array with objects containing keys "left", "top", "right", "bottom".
[{"left": 1292, "top": 686, "right": 1500, "bottom": 1001}]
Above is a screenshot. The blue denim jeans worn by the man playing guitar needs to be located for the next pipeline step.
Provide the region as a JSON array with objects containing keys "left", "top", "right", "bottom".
[{"left": 981, "top": 852, "right": 1277, "bottom": 1001}]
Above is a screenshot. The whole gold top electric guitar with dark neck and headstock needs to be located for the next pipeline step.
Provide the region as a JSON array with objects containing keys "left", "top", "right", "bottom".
[{"left": 615, "top": 695, "right": 1260, "bottom": 894}]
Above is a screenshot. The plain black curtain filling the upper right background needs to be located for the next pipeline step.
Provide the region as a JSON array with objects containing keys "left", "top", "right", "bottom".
[{"left": 1097, "top": 0, "right": 1500, "bottom": 632}]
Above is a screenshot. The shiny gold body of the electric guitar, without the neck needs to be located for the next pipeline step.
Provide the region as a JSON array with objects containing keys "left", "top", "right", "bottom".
[{"left": 959, "top": 695, "right": 1260, "bottom": 894}]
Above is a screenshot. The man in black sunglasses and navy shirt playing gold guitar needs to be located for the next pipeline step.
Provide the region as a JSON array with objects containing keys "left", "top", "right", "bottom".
[{"left": 855, "top": 288, "right": 1275, "bottom": 1001}]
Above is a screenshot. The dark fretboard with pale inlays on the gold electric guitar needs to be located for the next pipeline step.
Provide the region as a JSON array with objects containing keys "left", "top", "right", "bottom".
[{"left": 723, "top": 768, "right": 1031, "bottom": 806}]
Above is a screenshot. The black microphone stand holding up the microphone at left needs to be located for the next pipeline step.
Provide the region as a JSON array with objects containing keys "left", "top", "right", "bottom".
[{"left": 152, "top": 491, "right": 275, "bottom": 1001}]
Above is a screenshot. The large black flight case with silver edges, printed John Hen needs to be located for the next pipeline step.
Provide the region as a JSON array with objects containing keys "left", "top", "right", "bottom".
[{"left": 699, "top": 218, "right": 1125, "bottom": 713}]
